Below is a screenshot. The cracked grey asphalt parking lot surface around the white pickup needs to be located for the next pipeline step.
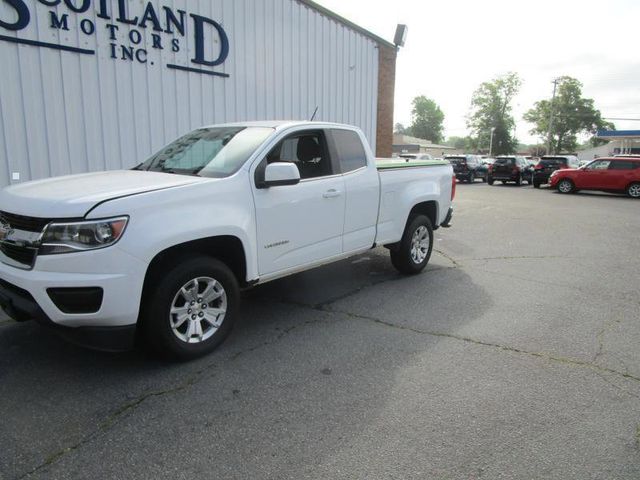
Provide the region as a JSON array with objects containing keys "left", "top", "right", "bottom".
[{"left": 0, "top": 182, "right": 640, "bottom": 480}]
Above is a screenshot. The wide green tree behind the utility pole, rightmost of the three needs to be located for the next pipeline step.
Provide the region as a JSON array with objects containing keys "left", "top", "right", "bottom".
[{"left": 524, "top": 76, "right": 615, "bottom": 153}]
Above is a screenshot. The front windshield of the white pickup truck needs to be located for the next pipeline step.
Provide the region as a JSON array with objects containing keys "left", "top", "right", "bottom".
[{"left": 134, "top": 127, "right": 274, "bottom": 178}]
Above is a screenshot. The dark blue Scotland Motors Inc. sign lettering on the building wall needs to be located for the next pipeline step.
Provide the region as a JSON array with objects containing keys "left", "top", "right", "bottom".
[{"left": 0, "top": 0, "right": 229, "bottom": 77}]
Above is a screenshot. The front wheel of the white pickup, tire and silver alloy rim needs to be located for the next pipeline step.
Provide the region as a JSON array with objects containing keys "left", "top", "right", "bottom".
[{"left": 140, "top": 256, "right": 240, "bottom": 360}]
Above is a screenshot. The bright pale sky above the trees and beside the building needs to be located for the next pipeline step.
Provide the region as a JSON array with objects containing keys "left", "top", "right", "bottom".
[{"left": 316, "top": 0, "right": 640, "bottom": 144}]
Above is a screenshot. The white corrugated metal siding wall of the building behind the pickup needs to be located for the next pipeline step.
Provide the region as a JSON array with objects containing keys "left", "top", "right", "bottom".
[{"left": 0, "top": 0, "right": 378, "bottom": 185}]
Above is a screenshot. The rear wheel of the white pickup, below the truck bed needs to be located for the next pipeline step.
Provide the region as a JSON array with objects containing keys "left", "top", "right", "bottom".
[{"left": 391, "top": 215, "right": 433, "bottom": 275}]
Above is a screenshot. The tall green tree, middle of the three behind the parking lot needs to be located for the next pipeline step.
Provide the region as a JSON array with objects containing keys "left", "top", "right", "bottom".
[{"left": 467, "top": 72, "right": 522, "bottom": 155}]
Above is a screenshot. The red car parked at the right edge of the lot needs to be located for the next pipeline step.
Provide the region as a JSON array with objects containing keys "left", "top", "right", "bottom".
[{"left": 549, "top": 157, "right": 640, "bottom": 198}]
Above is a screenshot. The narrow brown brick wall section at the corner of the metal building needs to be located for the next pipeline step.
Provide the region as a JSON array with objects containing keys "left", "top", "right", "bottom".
[{"left": 376, "top": 44, "right": 397, "bottom": 157}]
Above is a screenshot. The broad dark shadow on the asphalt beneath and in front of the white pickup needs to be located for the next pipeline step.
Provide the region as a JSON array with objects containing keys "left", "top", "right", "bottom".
[{"left": 0, "top": 249, "right": 488, "bottom": 478}]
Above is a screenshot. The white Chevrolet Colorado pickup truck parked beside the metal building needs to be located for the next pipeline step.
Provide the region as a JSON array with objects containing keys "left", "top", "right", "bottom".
[{"left": 0, "top": 122, "right": 455, "bottom": 359}]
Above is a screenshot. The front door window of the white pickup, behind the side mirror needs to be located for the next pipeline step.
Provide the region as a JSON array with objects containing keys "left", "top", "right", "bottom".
[{"left": 267, "top": 132, "right": 332, "bottom": 180}]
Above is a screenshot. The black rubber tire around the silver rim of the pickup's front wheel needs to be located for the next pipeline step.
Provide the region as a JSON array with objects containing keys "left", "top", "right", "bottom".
[{"left": 140, "top": 256, "right": 240, "bottom": 360}]
